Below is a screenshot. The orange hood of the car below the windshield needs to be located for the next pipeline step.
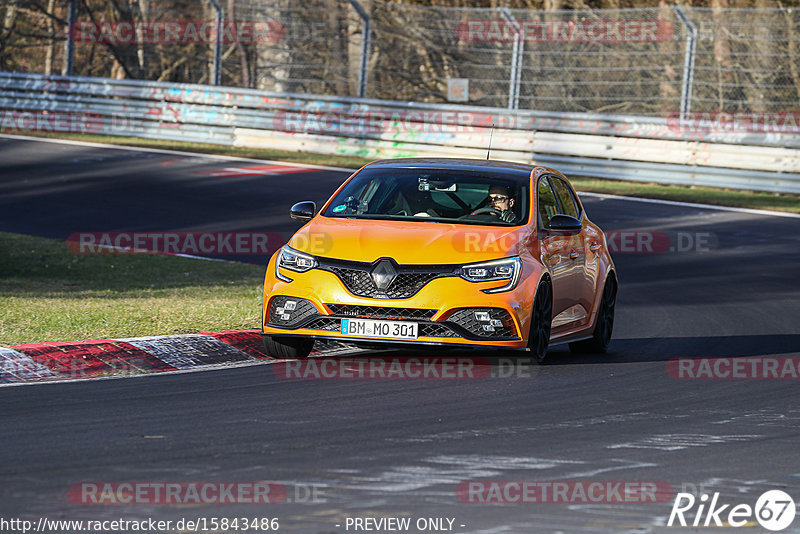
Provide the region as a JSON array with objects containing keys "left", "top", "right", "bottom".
[{"left": 289, "top": 216, "right": 530, "bottom": 264}]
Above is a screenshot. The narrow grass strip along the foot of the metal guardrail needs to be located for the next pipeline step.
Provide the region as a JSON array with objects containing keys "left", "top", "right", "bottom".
[{"left": 10, "top": 132, "right": 800, "bottom": 213}]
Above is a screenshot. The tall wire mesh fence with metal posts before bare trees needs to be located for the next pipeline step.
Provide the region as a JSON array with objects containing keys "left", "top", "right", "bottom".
[{"left": 0, "top": 0, "right": 800, "bottom": 116}]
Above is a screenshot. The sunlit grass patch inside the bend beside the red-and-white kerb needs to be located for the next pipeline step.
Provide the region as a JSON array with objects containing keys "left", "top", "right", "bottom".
[{"left": 0, "top": 232, "right": 264, "bottom": 346}]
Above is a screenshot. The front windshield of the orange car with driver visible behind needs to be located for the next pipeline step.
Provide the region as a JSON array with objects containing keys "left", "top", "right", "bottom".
[{"left": 323, "top": 169, "right": 528, "bottom": 226}]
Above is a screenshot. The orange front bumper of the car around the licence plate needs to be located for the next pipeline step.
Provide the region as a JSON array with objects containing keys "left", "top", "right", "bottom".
[{"left": 262, "top": 258, "right": 538, "bottom": 348}]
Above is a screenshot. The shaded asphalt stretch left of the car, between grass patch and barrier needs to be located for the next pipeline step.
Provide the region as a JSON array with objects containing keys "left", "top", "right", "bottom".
[{"left": 0, "top": 137, "right": 348, "bottom": 265}]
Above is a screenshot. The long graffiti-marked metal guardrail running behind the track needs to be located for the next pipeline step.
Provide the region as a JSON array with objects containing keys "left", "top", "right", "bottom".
[{"left": 0, "top": 73, "right": 800, "bottom": 193}]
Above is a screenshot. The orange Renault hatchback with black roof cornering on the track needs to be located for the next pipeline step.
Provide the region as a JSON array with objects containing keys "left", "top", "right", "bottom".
[{"left": 262, "top": 158, "right": 617, "bottom": 362}]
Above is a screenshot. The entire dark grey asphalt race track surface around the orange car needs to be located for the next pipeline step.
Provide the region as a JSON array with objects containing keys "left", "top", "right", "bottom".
[{"left": 0, "top": 135, "right": 800, "bottom": 533}]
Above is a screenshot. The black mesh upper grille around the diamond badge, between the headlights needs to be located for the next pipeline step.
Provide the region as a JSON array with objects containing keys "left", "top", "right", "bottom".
[{"left": 317, "top": 258, "right": 458, "bottom": 299}]
